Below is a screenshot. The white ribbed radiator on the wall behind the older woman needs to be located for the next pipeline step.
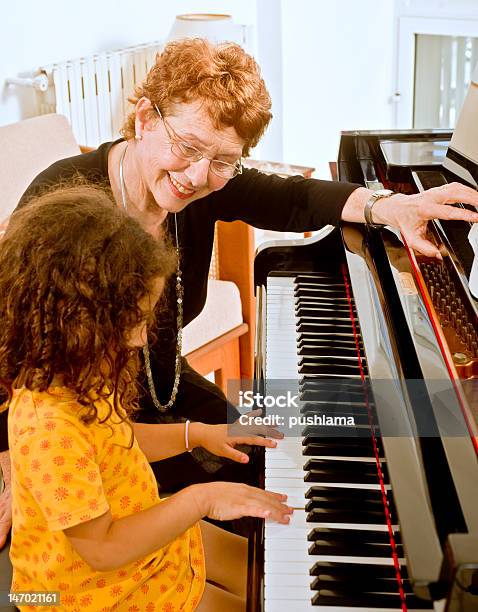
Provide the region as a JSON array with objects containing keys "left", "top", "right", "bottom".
[{"left": 37, "top": 42, "right": 163, "bottom": 147}]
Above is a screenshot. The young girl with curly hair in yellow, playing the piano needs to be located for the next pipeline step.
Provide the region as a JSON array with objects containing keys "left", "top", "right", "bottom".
[{"left": 0, "top": 185, "right": 291, "bottom": 612}]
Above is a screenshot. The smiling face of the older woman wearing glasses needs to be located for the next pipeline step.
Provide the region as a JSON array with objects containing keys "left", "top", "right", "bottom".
[{"left": 134, "top": 98, "right": 245, "bottom": 213}]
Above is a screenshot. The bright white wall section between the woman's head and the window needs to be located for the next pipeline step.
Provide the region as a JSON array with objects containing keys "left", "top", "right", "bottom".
[{"left": 282, "top": 0, "right": 394, "bottom": 178}]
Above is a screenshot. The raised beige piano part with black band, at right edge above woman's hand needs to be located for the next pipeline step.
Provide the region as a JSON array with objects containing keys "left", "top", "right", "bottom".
[{"left": 443, "top": 64, "right": 478, "bottom": 187}]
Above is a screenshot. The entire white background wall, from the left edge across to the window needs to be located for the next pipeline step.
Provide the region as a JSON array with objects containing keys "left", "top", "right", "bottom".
[{"left": 0, "top": 0, "right": 478, "bottom": 177}]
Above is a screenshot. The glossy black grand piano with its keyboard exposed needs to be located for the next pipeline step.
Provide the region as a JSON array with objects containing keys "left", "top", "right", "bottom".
[{"left": 248, "top": 70, "right": 478, "bottom": 612}]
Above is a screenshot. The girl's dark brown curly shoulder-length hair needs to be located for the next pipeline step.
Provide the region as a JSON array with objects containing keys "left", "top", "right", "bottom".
[{"left": 0, "top": 183, "right": 175, "bottom": 430}]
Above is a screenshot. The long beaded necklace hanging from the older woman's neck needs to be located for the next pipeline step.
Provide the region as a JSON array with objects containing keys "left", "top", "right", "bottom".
[{"left": 119, "top": 144, "right": 184, "bottom": 412}]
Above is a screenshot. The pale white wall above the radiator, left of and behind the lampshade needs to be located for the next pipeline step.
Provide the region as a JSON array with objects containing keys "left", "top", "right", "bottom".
[{"left": 0, "top": 0, "right": 256, "bottom": 125}]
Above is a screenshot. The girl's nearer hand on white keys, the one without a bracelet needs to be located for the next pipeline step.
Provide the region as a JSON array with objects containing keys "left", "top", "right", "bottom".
[{"left": 190, "top": 482, "right": 294, "bottom": 524}]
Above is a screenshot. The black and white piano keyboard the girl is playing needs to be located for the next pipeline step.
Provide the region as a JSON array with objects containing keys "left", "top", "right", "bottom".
[{"left": 264, "top": 273, "right": 439, "bottom": 612}]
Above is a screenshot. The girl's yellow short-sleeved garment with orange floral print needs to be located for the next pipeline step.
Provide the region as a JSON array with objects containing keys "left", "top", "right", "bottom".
[{"left": 8, "top": 387, "right": 206, "bottom": 612}]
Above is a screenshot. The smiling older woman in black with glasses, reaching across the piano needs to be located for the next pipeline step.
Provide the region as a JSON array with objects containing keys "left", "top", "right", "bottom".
[{"left": 0, "top": 39, "right": 478, "bottom": 548}]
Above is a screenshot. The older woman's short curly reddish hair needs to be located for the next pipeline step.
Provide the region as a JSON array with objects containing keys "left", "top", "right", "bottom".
[{"left": 121, "top": 38, "right": 272, "bottom": 156}]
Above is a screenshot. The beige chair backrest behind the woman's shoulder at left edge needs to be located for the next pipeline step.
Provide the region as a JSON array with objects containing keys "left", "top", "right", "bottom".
[{"left": 0, "top": 114, "right": 80, "bottom": 221}]
